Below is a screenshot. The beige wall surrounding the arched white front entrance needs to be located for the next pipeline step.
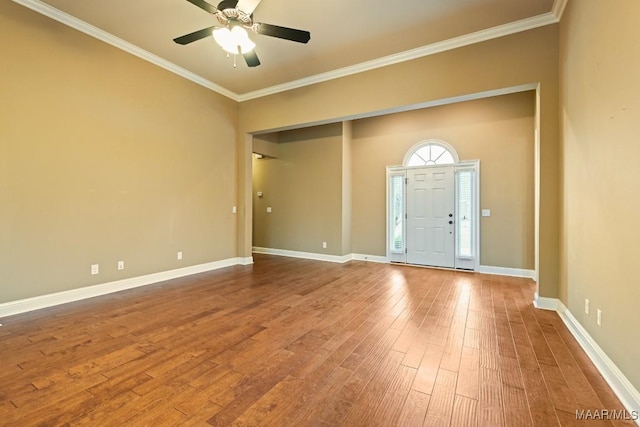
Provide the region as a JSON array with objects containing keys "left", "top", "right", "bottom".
[{"left": 352, "top": 91, "right": 535, "bottom": 270}]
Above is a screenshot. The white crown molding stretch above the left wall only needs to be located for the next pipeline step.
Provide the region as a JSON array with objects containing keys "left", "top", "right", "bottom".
[{"left": 12, "top": 0, "right": 238, "bottom": 101}]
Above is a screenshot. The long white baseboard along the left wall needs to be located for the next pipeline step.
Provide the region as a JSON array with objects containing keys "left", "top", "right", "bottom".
[{"left": 0, "top": 257, "right": 246, "bottom": 318}]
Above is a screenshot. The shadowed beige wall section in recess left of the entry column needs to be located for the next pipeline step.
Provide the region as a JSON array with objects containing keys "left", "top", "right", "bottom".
[{"left": 253, "top": 123, "right": 343, "bottom": 255}]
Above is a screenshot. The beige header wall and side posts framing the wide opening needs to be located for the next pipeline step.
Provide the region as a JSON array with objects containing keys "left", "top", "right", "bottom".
[{"left": 238, "top": 25, "right": 559, "bottom": 297}]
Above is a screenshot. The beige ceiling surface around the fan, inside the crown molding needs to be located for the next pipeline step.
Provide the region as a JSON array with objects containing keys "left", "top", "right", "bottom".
[{"left": 14, "top": 0, "right": 566, "bottom": 99}]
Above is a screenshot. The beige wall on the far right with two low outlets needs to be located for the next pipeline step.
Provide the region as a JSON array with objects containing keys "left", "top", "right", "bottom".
[{"left": 560, "top": 0, "right": 640, "bottom": 392}]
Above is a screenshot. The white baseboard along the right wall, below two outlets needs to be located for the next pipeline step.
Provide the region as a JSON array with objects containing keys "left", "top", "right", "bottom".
[{"left": 534, "top": 294, "right": 640, "bottom": 426}]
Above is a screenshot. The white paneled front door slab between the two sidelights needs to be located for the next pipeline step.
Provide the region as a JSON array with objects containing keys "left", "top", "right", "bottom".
[{"left": 406, "top": 165, "right": 455, "bottom": 268}]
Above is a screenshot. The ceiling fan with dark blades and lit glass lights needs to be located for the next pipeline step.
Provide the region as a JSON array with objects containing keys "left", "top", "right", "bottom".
[{"left": 173, "top": 0, "right": 311, "bottom": 67}]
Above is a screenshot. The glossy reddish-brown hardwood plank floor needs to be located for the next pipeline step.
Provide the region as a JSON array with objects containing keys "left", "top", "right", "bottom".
[{"left": 0, "top": 255, "right": 634, "bottom": 427}]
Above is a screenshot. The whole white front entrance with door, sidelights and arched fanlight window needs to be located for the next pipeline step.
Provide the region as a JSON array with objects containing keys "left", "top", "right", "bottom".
[{"left": 387, "top": 140, "right": 480, "bottom": 270}]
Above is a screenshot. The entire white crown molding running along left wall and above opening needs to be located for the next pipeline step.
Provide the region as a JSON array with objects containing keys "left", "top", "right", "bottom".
[{"left": 12, "top": 0, "right": 567, "bottom": 102}]
